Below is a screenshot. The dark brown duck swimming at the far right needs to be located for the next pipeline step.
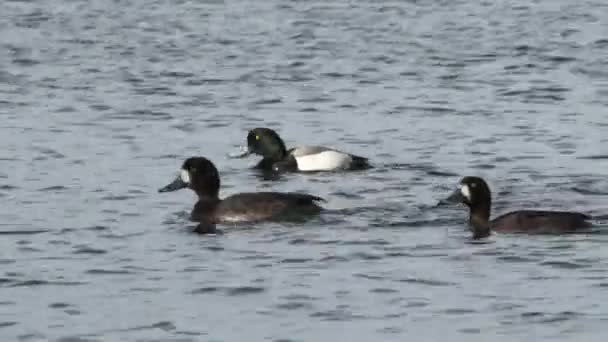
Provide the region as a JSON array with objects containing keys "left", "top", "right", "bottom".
[{"left": 440, "top": 176, "right": 591, "bottom": 239}]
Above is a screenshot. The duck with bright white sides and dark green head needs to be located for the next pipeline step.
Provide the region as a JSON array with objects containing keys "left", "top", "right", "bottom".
[{"left": 232, "top": 127, "right": 371, "bottom": 172}]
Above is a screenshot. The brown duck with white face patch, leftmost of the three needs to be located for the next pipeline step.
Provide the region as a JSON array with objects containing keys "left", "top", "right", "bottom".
[{"left": 158, "top": 157, "right": 325, "bottom": 234}]
